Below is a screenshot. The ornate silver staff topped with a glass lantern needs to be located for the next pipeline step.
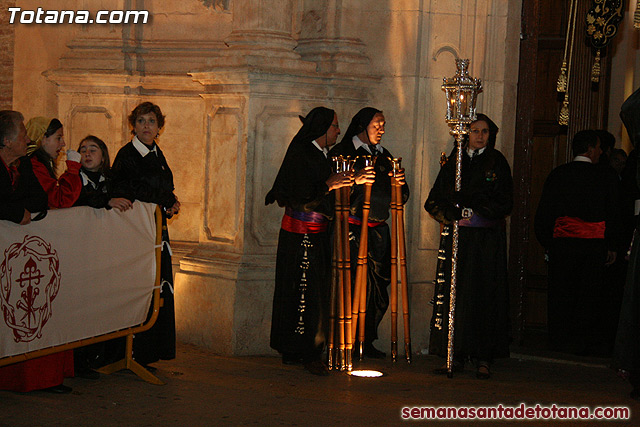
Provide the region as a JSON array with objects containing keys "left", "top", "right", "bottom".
[{"left": 442, "top": 59, "right": 482, "bottom": 378}]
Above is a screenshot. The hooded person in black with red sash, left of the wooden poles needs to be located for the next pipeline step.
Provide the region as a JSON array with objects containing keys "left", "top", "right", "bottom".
[{"left": 265, "top": 107, "right": 350, "bottom": 375}]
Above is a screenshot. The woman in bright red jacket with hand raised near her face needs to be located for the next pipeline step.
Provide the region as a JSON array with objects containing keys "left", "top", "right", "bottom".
[{"left": 27, "top": 117, "right": 82, "bottom": 209}]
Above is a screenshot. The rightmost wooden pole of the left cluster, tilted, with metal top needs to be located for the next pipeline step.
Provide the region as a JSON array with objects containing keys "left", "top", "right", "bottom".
[{"left": 351, "top": 156, "right": 375, "bottom": 360}]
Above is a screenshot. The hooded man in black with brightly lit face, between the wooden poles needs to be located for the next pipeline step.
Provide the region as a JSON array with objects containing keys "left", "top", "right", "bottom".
[{"left": 329, "top": 107, "right": 409, "bottom": 358}]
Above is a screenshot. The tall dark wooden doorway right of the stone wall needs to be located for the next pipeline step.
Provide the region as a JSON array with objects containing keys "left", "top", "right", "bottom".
[{"left": 509, "top": 0, "right": 611, "bottom": 349}]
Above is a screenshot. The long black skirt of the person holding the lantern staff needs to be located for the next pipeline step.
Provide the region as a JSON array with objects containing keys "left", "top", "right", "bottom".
[{"left": 429, "top": 226, "right": 509, "bottom": 362}]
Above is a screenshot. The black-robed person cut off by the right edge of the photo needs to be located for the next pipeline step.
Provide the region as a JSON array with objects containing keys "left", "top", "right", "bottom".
[{"left": 613, "top": 89, "right": 640, "bottom": 400}]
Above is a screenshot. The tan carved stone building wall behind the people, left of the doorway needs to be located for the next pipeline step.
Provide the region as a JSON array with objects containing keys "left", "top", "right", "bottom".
[{"left": 6, "top": 0, "right": 520, "bottom": 354}]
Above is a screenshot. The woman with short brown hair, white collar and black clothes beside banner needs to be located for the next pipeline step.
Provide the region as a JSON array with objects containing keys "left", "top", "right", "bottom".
[{"left": 111, "top": 102, "right": 180, "bottom": 365}]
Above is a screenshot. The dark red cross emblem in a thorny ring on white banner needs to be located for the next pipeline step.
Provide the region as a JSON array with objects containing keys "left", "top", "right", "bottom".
[{"left": 0, "top": 236, "right": 60, "bottom": 342}]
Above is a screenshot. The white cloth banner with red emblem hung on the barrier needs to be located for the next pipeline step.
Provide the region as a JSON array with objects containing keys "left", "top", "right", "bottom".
[{"left": 0, "top": 202, "right": 156, "bottom": 358}]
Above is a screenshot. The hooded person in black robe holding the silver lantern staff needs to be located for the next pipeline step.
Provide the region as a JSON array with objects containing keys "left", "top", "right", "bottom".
[{"left": 424, "top": 114, "right": 513, "bottom": 379}]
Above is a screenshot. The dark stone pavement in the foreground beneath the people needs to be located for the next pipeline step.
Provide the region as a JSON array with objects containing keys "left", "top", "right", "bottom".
[{"left": 0, "top": 344, "right": 640, "bottom": 427}]
